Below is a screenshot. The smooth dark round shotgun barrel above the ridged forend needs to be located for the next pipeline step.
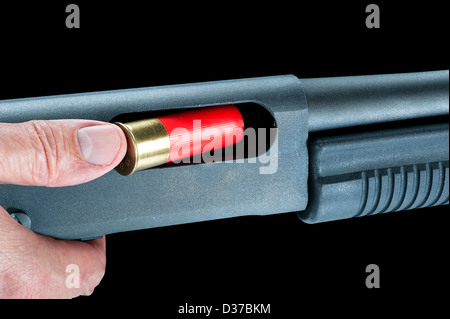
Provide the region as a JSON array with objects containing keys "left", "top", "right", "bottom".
[{"left": 301, "top": 70, "right": 449, "bottom": 132}]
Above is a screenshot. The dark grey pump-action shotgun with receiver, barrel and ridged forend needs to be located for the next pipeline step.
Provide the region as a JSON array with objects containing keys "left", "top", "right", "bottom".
[{"left": 0, "top": 70, "right": 449, "bottom": 240}]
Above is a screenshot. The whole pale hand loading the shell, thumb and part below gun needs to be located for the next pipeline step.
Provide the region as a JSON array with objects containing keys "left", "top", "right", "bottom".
[{"left": 0, "top": 120, "right": 127, "bottom": 298}]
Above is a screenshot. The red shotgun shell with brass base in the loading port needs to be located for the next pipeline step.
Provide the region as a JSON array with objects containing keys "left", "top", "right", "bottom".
[{"left": 116, "top": 104, "right": 244, "bottom": 175}]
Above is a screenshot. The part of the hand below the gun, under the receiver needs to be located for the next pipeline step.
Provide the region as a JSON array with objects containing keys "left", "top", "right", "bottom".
[{"left": 0, "top": 207, "right": 106, "bottom": 298}]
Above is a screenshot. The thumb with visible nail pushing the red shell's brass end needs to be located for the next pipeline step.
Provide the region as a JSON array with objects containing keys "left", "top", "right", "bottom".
[{"left": 0, "top": 120, "right": 127, "bottom": 186}]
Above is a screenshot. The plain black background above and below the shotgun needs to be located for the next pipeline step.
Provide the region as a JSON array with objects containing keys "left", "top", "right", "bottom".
[{"left": 0, "top": 0, "right": 449, "bottom": 318}]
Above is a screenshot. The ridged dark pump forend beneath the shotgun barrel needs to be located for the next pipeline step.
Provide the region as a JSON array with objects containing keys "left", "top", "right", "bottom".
[{"left": 299, "top": 123, "right": 449, "bottom": 223}]
